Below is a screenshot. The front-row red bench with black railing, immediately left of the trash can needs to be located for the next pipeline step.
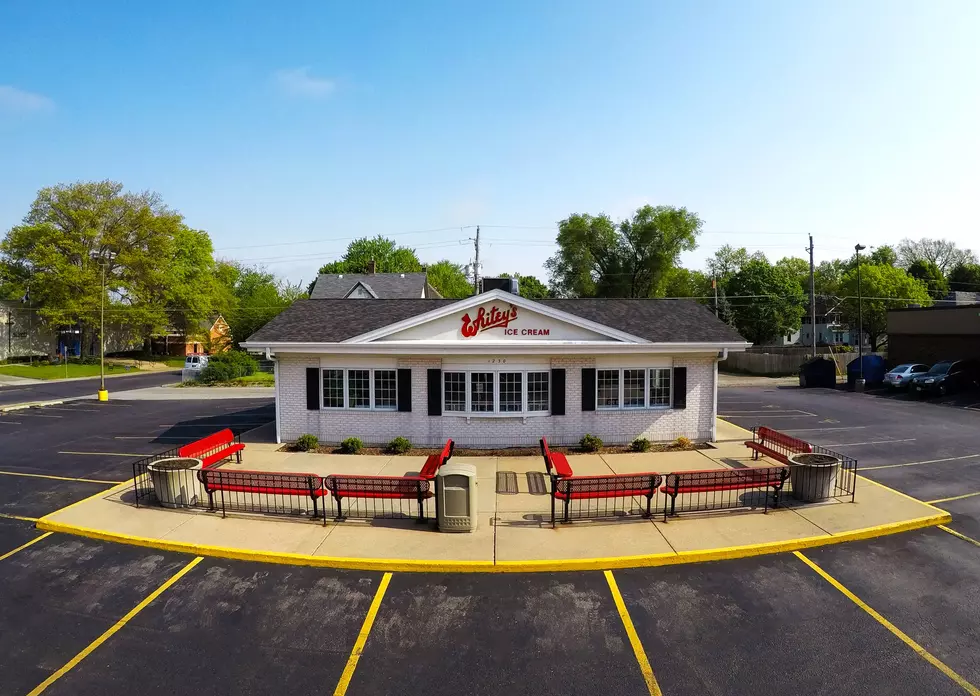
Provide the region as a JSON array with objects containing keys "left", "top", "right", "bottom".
[{"left": 323, "top": 474, "right": 433, "bottom": 522}]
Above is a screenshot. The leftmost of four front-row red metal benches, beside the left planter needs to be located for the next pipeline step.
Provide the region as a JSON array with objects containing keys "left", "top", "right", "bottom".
[{"left": 197, "top": 468, "right": 327, "bottom": 524}]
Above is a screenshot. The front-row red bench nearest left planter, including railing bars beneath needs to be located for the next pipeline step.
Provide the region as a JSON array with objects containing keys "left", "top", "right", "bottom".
[{"left": 196, "top": 468, "right": 326, "bottom": 524}]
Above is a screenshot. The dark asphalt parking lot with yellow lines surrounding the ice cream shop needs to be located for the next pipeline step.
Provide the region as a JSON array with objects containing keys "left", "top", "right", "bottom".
[{"left": 0, "top": 389, "right": 980, "bottom": 696}]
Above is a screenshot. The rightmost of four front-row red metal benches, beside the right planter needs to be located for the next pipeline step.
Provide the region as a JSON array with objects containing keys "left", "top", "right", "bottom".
[{"left": 660, "top": 466, "right": 789, "bottom": 522}]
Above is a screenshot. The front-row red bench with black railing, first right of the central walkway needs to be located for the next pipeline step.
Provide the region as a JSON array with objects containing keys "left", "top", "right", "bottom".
[{"left": 551, "top": 473, "right": 661, "bottom": 527}]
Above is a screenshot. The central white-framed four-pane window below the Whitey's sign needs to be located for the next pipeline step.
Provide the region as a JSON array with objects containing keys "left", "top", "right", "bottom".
[{"left": 442, "top": 370, "right": 551, "bottom": 415}]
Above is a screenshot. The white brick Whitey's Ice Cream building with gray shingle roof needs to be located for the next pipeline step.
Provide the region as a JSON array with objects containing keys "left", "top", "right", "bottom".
[{"left": 244, "top": 290, "right": 748, "bottom": 447}]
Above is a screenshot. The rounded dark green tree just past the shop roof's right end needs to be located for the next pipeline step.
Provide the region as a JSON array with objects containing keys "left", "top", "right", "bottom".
[{"left": 726, "top": 259, "right": 806, "bottom": 343}]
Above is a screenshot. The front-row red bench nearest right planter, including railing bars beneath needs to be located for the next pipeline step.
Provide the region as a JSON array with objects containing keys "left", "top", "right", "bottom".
[{"left": 661, "top": 466, "right": 789, "bottom": 522}]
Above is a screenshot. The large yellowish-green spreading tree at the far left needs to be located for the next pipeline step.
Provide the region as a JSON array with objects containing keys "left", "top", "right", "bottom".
[{"left": 0, "top": 181, "right": 213, "bottom": 352}]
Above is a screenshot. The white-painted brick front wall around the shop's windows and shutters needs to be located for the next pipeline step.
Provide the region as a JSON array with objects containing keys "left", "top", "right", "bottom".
[{"left": 277, "top": 355, "right": 715, "bottom": 447}]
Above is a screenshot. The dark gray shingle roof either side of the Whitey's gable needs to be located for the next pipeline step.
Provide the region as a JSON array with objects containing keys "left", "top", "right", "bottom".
[{"left": 248, "top": 299, "right": 744, "bottom": 344}]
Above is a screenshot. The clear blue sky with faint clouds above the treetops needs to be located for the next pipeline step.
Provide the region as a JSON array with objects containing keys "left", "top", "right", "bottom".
[{"left": 0, "top": 0, "right": 980, "bottom": 281}]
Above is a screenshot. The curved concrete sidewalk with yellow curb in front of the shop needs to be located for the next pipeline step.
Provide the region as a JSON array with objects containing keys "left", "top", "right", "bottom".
[{"left": 38, "top": 424, "right": 949, "bottom": 571}]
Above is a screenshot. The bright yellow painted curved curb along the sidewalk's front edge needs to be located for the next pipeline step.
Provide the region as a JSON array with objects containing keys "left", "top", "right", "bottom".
[{"left": 37, "top": 512, "right": 953, "bottom": 573}]
